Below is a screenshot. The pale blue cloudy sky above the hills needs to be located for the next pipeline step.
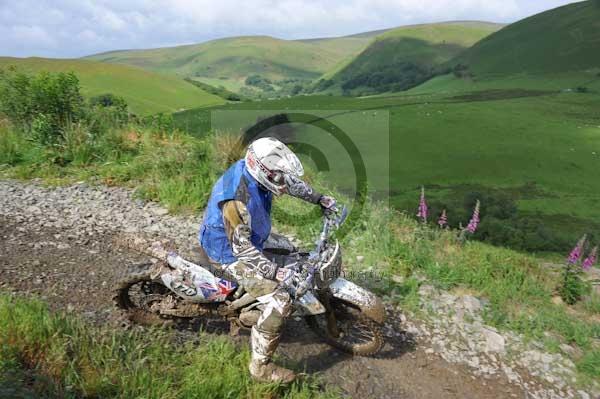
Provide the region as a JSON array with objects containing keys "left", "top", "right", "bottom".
[{"left": 0, "top": 0, "right": 573, "bottom": 58}]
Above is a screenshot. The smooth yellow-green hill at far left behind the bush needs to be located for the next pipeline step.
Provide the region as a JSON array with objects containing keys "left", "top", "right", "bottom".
[{"left": 0, "top": 57, "right": 225, "bottom": 115}]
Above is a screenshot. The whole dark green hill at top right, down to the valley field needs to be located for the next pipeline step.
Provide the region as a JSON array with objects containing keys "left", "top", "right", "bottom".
[{"left": 409, "top": 0, "right": 600, "bottom": 95}]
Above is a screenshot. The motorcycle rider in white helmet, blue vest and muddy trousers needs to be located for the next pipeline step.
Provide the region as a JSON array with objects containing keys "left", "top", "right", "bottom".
[{"left": 198, "top": 137, "right": 336, "bottom": 383}]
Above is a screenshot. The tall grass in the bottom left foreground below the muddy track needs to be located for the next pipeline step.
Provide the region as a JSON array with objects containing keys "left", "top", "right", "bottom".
[{"left": 0, "top": 294, "right": 335, "bottom": 399}]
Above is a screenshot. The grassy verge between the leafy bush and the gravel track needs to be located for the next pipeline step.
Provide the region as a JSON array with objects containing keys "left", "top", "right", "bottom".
[{"left": 0, "top": 127, "right": 215, "bottom": 211}]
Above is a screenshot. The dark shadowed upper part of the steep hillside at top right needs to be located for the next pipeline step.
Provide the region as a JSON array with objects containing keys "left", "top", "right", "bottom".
[{"left": 452, "top": 0, "right": 600, "bottom": 75}]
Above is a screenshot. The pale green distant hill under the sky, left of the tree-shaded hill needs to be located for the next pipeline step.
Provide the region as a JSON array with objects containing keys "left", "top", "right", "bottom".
[{"left": 88, "top": 36, "right": 370, "bottom": 84}]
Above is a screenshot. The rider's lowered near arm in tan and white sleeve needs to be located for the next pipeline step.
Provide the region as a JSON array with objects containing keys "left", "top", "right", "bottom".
[{"left": 222, "top": 200, "right": 278, "bottom": 279}]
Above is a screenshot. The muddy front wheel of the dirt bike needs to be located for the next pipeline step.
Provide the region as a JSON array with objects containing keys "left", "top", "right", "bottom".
[{"left": 306, "top": 298, "right": 384, "bottom": 356}]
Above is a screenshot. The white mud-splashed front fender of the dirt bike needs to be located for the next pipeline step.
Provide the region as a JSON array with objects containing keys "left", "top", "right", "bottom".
[{"left": 329, "top": 277, "right": 385, "bottom": 324}]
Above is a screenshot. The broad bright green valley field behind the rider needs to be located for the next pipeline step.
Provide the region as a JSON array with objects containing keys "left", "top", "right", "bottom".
[{"left": 176, "top": 85, "right": 600, "bottom": 252}]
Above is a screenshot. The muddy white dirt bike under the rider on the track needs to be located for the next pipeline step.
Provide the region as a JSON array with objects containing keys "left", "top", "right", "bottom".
[{"left": 114, "top": 208, "right": 385, "bottom": 356}]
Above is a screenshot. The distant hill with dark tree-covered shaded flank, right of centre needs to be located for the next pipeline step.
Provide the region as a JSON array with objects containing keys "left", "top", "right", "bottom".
[{"left": 324, "top": 21, "right": 502, "bottom": 92}]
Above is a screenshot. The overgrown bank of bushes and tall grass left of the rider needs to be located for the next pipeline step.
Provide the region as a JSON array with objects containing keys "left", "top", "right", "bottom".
[{"left": 0, "top": 70, "right": 221, "bottom": 210}]
